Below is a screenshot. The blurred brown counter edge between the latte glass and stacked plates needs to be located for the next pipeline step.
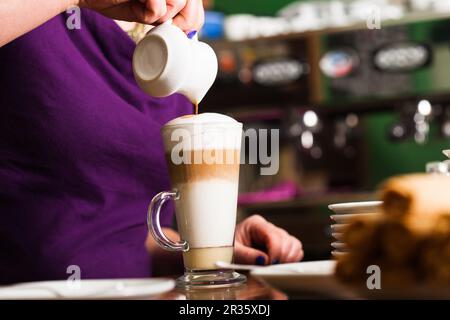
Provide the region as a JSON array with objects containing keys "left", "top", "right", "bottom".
[{"left": 239, "top": 192, "right": 378, "bottom": 211}]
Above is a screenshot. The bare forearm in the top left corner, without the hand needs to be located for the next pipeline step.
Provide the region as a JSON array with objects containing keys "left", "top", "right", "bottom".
[{"left": 0, "top": 0, "right": 78, "bottom": 47}]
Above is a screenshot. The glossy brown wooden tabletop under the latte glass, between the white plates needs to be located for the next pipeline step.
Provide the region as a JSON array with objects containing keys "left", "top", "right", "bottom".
[{"left": 155, "top": 275, "right": 288, "bottom": 300}]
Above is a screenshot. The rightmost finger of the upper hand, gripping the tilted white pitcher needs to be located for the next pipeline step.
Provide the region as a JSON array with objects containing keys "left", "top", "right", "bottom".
[{"left": 173, "top": 0, "right": 205, "bottom": 32}]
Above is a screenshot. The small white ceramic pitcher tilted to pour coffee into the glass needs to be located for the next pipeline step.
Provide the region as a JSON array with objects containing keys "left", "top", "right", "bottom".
[{"left": 133, "top": 20, "right": 217, "bottom": 104}]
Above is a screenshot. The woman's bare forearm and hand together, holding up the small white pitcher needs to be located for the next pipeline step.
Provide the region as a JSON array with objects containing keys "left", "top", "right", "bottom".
[{"left": 0, "top": 0, "right": 204, "bottom": 47}]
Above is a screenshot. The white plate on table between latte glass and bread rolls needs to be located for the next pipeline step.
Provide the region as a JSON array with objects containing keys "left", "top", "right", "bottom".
[{"left": 251, "top": 260, "right": 356, "bottom": 298}]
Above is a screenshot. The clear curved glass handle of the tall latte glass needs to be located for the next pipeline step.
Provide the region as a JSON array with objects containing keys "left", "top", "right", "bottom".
[{"left": 147, "top": 190, "right": 189, "bottom": 251}]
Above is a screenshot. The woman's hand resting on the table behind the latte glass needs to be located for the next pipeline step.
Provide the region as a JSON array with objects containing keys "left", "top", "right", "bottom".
[{"left": 234, "top": 215, "right": 303, "bottom": 265}]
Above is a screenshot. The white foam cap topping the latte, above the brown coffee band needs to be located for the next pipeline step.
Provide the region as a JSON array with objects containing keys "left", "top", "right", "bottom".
[{"left": 162, "top": 113, "right": 242, "bottom": 153}]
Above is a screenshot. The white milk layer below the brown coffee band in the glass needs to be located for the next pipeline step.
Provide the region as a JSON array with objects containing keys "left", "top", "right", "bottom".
[{"left": 174, "top": 179, "right": 238, "bottom": 248}]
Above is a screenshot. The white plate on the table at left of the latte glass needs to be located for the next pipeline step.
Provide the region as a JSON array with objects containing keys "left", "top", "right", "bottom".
[{"left": 0, "top": 278, "right": 175, "bottom": 300}]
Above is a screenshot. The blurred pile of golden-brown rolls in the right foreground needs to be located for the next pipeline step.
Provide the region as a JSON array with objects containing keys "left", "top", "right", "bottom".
[{"left": 336, "top": 174, "right": 450, "bottom": 287}]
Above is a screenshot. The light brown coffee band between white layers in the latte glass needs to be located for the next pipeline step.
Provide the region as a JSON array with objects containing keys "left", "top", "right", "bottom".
[{"left": 166, "top": 150, "right": 240, "bottom": 184}]
